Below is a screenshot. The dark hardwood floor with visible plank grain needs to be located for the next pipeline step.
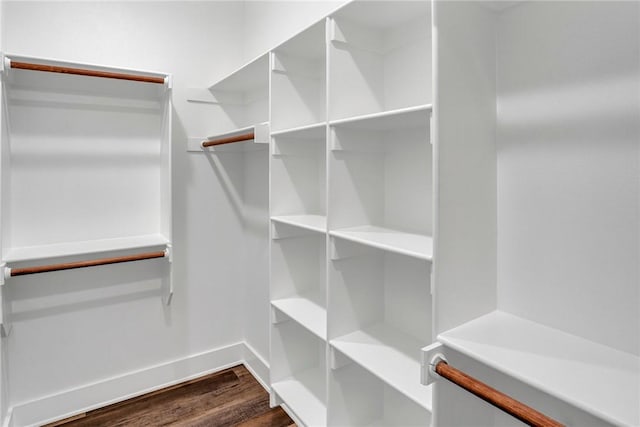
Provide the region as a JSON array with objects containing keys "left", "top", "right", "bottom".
[{"left": 45, "top": 365, "right": 295, "bottom": 427}]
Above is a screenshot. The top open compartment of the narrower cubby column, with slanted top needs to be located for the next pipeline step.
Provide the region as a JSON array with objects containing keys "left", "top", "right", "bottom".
[{"left": 271, "top": 20, "right": 326, "bottom": 131}]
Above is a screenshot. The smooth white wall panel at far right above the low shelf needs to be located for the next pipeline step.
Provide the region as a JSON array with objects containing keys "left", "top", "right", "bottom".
[{"left": 497, "top": 1, "right": 640, "bottom": 355}]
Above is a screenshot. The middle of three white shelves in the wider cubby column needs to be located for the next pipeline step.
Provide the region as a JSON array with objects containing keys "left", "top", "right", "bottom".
[{"left": 329, "top": 225, "right": 433, "bottom": 261}]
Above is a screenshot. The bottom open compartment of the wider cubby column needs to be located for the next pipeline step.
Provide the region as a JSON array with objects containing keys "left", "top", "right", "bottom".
[{"left": 327, "top": 363, "right": 431, "bottom": 427}]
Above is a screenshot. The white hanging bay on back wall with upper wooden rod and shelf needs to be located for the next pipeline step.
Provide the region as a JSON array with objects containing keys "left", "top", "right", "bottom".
[{"left": 0, "top": 55, "right": 172, "bottom": 318}]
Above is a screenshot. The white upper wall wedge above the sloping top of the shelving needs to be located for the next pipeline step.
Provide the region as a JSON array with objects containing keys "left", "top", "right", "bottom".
[{"left": 243, "top": 0, "right": 347, "bottom": 61}]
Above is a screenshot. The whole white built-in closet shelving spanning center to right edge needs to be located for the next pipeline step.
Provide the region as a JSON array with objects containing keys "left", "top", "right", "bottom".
[{"left": 186, "top": 1, "right": 640, "bottom": 426}]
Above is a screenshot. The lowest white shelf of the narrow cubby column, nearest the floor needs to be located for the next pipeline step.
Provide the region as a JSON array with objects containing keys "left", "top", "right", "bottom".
[{"left": 271, "top": 369, "right": 327, "bottom": 426}]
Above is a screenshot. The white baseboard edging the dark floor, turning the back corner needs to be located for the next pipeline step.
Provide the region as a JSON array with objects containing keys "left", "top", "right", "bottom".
[{"left": 10, "top": 342, "right": 246, "bottom": 427}]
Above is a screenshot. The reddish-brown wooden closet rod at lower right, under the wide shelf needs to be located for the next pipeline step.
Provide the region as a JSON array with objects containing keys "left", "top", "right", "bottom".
[{"left": 435, "top": 360, "right": 564, "bottom": 427}]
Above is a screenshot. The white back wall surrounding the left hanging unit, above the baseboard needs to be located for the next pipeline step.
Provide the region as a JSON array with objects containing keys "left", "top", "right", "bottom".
[{"left": 2, "top": 1, "right": 249, "bottom": 422}]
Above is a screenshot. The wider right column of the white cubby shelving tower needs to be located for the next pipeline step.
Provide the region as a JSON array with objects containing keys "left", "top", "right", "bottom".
[{"left": 327, "top": 1, "right": 433, "bottom": 426}]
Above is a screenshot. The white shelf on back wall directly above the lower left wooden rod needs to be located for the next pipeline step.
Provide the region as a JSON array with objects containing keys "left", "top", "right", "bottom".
[{"left": 3, "top": 234, "right": 169, "bottom": 262}]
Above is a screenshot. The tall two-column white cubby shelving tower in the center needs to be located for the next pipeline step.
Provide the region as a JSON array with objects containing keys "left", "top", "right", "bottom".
[{"left": 270, "top": 2, "right": 433, "bottom": 426}]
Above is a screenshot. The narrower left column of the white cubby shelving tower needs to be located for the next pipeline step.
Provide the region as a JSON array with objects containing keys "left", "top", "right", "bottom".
[{"left": 270, "top": 20, "right": 327, "bottom": 426}]
